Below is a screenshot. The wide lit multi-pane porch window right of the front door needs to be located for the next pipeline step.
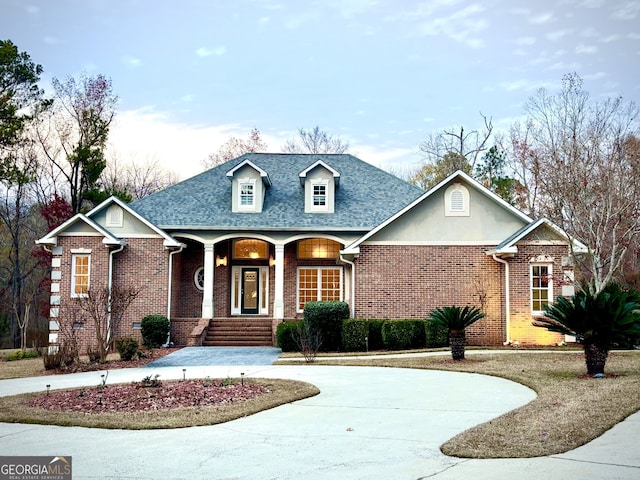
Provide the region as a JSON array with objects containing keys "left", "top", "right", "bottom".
[{"left": 298, "top": 267, "right": 342, "bottom": 312}]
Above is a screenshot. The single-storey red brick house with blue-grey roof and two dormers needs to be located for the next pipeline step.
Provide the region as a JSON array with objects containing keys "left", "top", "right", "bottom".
[{"left": 38, "top": 153, "right": 574, "bottom": 347}]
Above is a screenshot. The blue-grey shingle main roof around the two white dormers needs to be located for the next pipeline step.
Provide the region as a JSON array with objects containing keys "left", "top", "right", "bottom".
[{"left": 130, "top": 153, "right": 424, "bottom": 230}]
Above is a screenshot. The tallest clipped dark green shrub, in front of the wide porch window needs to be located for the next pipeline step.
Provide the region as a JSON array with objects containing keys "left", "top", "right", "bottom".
[{"left": 304, "top": 302, "right": 350, "bottom": 351}]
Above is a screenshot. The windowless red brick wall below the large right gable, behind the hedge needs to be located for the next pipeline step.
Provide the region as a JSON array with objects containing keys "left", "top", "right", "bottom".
[{"left": 355, "top": 245, "right": 506, "bottom": 345}]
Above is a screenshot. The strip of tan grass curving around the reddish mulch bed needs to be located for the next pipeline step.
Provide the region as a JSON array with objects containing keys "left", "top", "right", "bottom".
[{"left": 0, "top": 379, "right": 320, "bottom": 430}]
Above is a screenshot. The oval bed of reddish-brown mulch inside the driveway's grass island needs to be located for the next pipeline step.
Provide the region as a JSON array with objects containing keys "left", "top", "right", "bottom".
[{"left": 29, "top": 377, "right": 269, "bottom": 414}]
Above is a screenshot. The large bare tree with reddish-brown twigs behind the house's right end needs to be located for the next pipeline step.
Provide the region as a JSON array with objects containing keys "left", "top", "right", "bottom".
[{"left": 523, "top": 73, "right": 640, "bottom": 293}]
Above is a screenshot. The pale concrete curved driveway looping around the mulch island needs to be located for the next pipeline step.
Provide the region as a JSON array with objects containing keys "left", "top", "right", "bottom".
[{"left": 0, "top": 366, "right": 640, "bottom": 480}]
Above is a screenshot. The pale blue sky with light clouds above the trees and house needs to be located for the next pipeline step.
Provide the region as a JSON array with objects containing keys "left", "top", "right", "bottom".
[{"left": 0, "top": 0, "right": 640, "bottom": 179}]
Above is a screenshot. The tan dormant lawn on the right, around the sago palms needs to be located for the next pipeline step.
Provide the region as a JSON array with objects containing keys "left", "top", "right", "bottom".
[{"left": 282, "top": 351, "right": 640, "bottom": 458}]
